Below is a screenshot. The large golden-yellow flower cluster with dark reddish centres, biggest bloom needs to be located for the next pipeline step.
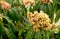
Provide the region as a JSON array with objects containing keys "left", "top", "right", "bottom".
[{"left": 27, "top": 11, "right": 52, "bottom": 31}]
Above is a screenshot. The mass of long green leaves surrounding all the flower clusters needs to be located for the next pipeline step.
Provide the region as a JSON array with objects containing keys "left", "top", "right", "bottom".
[{"left": 0, "top": 0, "right": 60, "bottom": 39}]
